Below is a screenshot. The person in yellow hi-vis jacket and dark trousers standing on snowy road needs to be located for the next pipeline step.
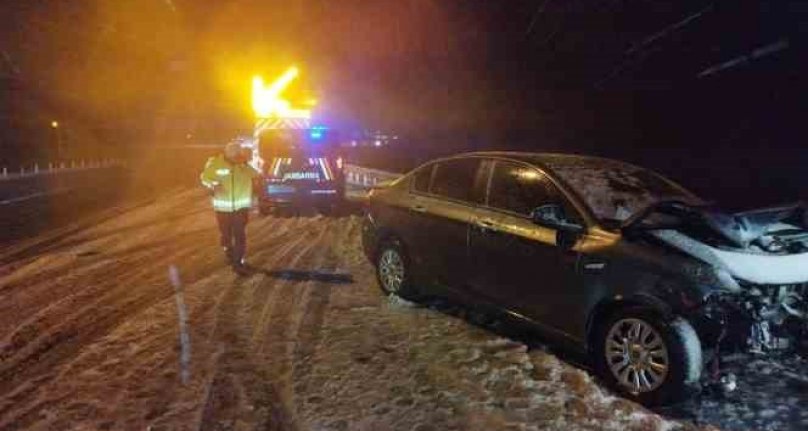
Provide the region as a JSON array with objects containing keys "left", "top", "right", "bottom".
[{"left": 200, "top": 142, "right": 260, "bottom": 272}]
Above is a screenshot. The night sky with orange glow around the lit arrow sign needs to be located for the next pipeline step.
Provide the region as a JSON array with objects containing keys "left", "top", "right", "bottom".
[{"left": 0, "top": 0, "right": 808, "bottom": 206}]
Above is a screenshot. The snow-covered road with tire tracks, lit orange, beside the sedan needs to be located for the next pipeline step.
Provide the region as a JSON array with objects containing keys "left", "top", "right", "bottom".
[{"left": 0, "top": 191, "right": 796, "bottom": 431}]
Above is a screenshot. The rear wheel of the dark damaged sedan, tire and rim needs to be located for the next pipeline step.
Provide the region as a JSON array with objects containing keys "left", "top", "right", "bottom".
[{"left": 375, "top": 240, "right": 419, "bottom": 300}]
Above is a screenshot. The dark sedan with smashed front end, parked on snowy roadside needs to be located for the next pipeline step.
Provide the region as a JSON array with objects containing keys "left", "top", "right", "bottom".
[{"left": 363, "top": 152, "right": 808, "bottom": 404}]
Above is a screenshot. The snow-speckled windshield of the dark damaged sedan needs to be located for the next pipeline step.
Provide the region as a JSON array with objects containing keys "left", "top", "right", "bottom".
[{"left": 550, "top": 159, "right": 703, "bottom": 225}]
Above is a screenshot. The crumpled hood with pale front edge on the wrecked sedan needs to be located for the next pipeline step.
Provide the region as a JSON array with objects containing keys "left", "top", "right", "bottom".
[{"left": 646, "top": 205, "right": 808, "bottom": 284}]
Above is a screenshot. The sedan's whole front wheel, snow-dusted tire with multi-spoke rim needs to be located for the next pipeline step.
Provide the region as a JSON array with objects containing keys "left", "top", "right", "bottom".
[{"left": 592, "top": 308, "right": 702, "bottom": 406}]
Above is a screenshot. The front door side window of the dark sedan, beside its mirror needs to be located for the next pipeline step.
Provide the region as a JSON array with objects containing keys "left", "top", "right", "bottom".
[{"left": 488, "top": 161, "right": 561, "bottom": 216}]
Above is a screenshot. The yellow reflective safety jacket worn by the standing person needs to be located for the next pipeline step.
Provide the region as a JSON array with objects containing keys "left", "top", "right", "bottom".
[{"left": 199, "top": 155, "right": 260, "bottom": 212}]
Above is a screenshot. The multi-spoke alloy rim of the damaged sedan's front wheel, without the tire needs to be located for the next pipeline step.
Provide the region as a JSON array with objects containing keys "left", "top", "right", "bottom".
[{"left": 605, "top": 318, "right": 670, "bottom": 394}]
